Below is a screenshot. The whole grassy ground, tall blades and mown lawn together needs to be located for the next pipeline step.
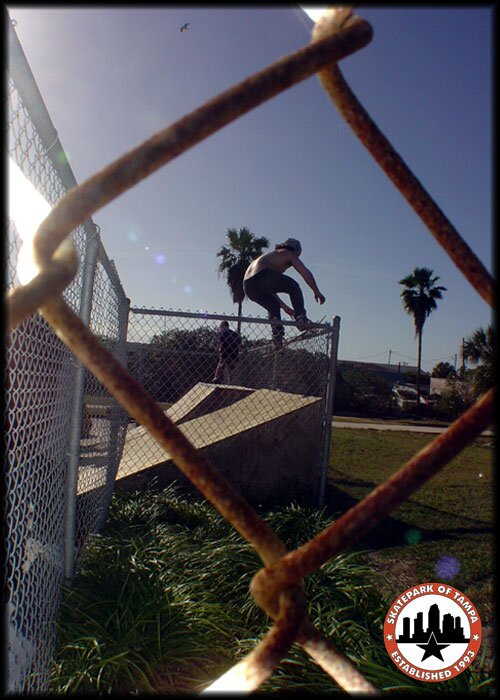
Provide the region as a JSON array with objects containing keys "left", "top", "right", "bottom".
[{"left": 51, "top": 428, "right": 495, "bottom": 696}]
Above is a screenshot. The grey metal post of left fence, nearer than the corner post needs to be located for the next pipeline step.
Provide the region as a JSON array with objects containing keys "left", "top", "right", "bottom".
[{"left": 64, "top": 224, "right": 100, "bottom": 579}]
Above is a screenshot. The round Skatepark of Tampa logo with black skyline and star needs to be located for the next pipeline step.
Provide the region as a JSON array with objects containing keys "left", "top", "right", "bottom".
[{"left": 384, "top": 583, "right": 481, "bottom": 683}]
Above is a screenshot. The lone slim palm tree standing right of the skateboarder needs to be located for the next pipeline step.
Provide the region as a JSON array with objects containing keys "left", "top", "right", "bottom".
[{"left": 399, "top": 267, "right": 446, "bottom": 412}]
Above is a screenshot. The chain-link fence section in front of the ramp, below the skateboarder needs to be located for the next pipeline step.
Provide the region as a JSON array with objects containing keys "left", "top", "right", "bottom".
[{"left": 118, "top": 308, "right": 340, "bottom": 503}]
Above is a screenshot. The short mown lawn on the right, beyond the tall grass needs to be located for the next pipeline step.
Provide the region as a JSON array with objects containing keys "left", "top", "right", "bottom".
[{"left": 328, "top": 428, "right": 494, "bottom": 626}]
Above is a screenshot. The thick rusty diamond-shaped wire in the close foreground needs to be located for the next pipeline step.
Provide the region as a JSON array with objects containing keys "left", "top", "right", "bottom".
[{"left": 7, "top": 8, "right": 493, "bottom": 694}]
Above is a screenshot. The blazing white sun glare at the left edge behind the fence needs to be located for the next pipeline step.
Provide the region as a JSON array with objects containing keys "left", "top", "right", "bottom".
[{"left": 9, "top": 158, "right": 52, "bottom": 284}]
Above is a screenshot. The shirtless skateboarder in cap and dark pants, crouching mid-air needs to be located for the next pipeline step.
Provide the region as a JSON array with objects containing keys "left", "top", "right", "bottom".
[{"left": 243, "top": 238, "right": 325, "bottom": 349}]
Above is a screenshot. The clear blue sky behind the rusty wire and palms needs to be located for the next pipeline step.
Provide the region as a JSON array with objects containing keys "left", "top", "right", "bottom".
[{"left": 8, "top": 5, "right": 493, "bottom": 371}]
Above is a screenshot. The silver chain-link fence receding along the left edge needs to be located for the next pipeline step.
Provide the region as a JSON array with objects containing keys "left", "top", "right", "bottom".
[{"left": 5, "top": 19, "right": 128, "bottom": 693}]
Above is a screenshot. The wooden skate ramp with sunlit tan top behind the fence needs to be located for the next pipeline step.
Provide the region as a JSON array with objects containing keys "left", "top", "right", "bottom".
[{"left": 116, "top": 383, "right": 323, "bottom": 502}]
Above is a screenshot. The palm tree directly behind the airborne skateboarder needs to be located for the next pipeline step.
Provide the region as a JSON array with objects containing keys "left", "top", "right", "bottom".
[{"left": 217, "top": 226, "right": 269, "bottom": 333}]
